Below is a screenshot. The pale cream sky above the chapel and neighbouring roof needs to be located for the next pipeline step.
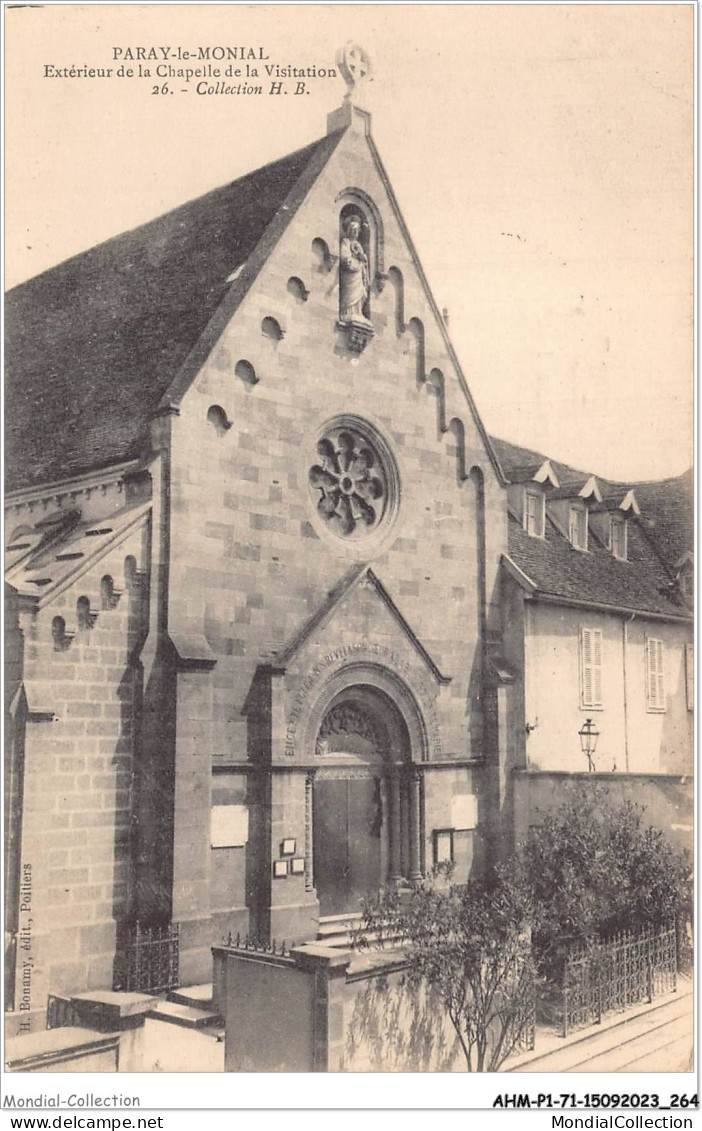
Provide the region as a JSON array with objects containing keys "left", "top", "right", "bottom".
[{"left": 6, "top": 3, "right": 693, "bottom": 482}]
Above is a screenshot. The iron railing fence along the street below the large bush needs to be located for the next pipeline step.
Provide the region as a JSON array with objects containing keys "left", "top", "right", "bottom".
[{"left": 562, "top": 924, "right": 677, "bottom": 1037}]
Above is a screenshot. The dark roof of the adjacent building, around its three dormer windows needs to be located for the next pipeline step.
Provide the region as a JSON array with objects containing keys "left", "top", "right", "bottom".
[{"left": 492, "top": 437, "right": 693, "bottom": 616}]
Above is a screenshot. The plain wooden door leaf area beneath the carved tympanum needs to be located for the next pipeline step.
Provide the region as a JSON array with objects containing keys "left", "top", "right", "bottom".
[{"left": 312, "top": 770, "right": 388, "bottom": 916}]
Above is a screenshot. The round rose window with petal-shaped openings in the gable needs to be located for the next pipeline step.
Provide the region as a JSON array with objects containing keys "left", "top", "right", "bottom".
[{"left": 310, "top": 426, "right": 389, "bottom": 538}]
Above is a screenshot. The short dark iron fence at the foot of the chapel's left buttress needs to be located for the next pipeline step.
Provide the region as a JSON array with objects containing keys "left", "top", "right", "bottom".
[{"left": 114, "top": 923, "right": 180, "bottom": 994}]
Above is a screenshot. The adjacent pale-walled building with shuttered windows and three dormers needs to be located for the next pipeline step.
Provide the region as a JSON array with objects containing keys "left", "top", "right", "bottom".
[{"left": 493, "top": 439, "right": 694, "bottom": 847}]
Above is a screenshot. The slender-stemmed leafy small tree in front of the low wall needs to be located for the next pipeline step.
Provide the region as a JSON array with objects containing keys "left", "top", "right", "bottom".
[{"left": 359, "top": 870, "right": 535, "bottom": 1072}]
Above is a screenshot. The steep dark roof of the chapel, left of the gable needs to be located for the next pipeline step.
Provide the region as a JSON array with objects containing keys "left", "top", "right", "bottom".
[{"left": 5, "top": 131, "right": 343, "bottom": 490}]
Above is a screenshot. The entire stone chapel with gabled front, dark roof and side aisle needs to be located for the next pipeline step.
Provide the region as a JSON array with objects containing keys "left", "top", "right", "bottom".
[{"left": 6, "top": 57, "right": 691, "bottom": 1030}]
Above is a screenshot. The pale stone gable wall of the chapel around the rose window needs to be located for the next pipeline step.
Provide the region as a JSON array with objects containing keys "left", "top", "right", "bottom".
[{"left": 162, "top": 126, "right": 506, "bottom": 927}]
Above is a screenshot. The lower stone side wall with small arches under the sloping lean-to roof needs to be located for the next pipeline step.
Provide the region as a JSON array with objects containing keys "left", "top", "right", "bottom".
[{"left": 12, "top": 520, "right": 148, "bottom": 1026}]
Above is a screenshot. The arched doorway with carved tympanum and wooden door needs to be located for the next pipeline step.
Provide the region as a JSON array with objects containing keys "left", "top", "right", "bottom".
[{"left": 312, "top": 684, "right": 410, "bottom": 917}]
